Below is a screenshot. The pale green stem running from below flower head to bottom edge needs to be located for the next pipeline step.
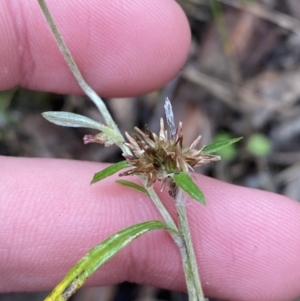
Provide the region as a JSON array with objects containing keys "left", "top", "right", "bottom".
[{"left": 175, "top": 188, "right": 206, "bottom": 301}]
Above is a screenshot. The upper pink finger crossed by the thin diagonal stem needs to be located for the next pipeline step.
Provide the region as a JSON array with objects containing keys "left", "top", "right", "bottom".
[{"left": 0, "top": 0, "right": 190, "bottom": 97}]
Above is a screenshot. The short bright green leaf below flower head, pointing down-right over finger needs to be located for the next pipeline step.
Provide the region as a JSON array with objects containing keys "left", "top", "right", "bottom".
[{"left": 173, "top": 172, "right": 205, "bottom": 205}]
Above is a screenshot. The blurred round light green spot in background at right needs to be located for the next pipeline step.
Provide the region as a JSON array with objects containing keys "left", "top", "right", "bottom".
[{"left": 246, "top": 133, "right": 272, "bottom": 157}]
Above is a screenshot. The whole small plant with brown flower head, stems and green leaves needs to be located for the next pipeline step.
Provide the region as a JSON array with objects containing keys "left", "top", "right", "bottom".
[{"left": 38, "top": 0, "right": 241, "bottom": 301}]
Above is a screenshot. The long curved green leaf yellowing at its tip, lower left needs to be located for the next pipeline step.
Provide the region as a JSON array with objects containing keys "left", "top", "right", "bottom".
[{"left": 45, "top": 221, "right": 172, "bottom": 301}]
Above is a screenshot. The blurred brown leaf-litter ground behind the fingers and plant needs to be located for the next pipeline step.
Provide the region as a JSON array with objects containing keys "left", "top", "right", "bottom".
[{"left": 0, "top": 0, "right": 300, "bottom": 301}]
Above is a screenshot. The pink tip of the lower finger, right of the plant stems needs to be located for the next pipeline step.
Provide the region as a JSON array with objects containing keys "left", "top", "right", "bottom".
[{"left": 189, "top": 177, "right": 300, "bottom": 301}]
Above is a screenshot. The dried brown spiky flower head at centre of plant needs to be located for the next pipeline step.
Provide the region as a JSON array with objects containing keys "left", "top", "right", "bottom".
[{"left": 120, "top": 115, "right": 220, "bottom": 197}]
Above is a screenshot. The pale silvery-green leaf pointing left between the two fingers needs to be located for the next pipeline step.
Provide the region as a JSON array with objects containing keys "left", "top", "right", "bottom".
[{"left": 42, "top": 112, "right": 105, "bottom": 131}]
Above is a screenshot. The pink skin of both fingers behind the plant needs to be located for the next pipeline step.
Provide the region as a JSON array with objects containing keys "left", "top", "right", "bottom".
[{"left": 0, "top": 0, "right": 300, "bottom": 301}]
